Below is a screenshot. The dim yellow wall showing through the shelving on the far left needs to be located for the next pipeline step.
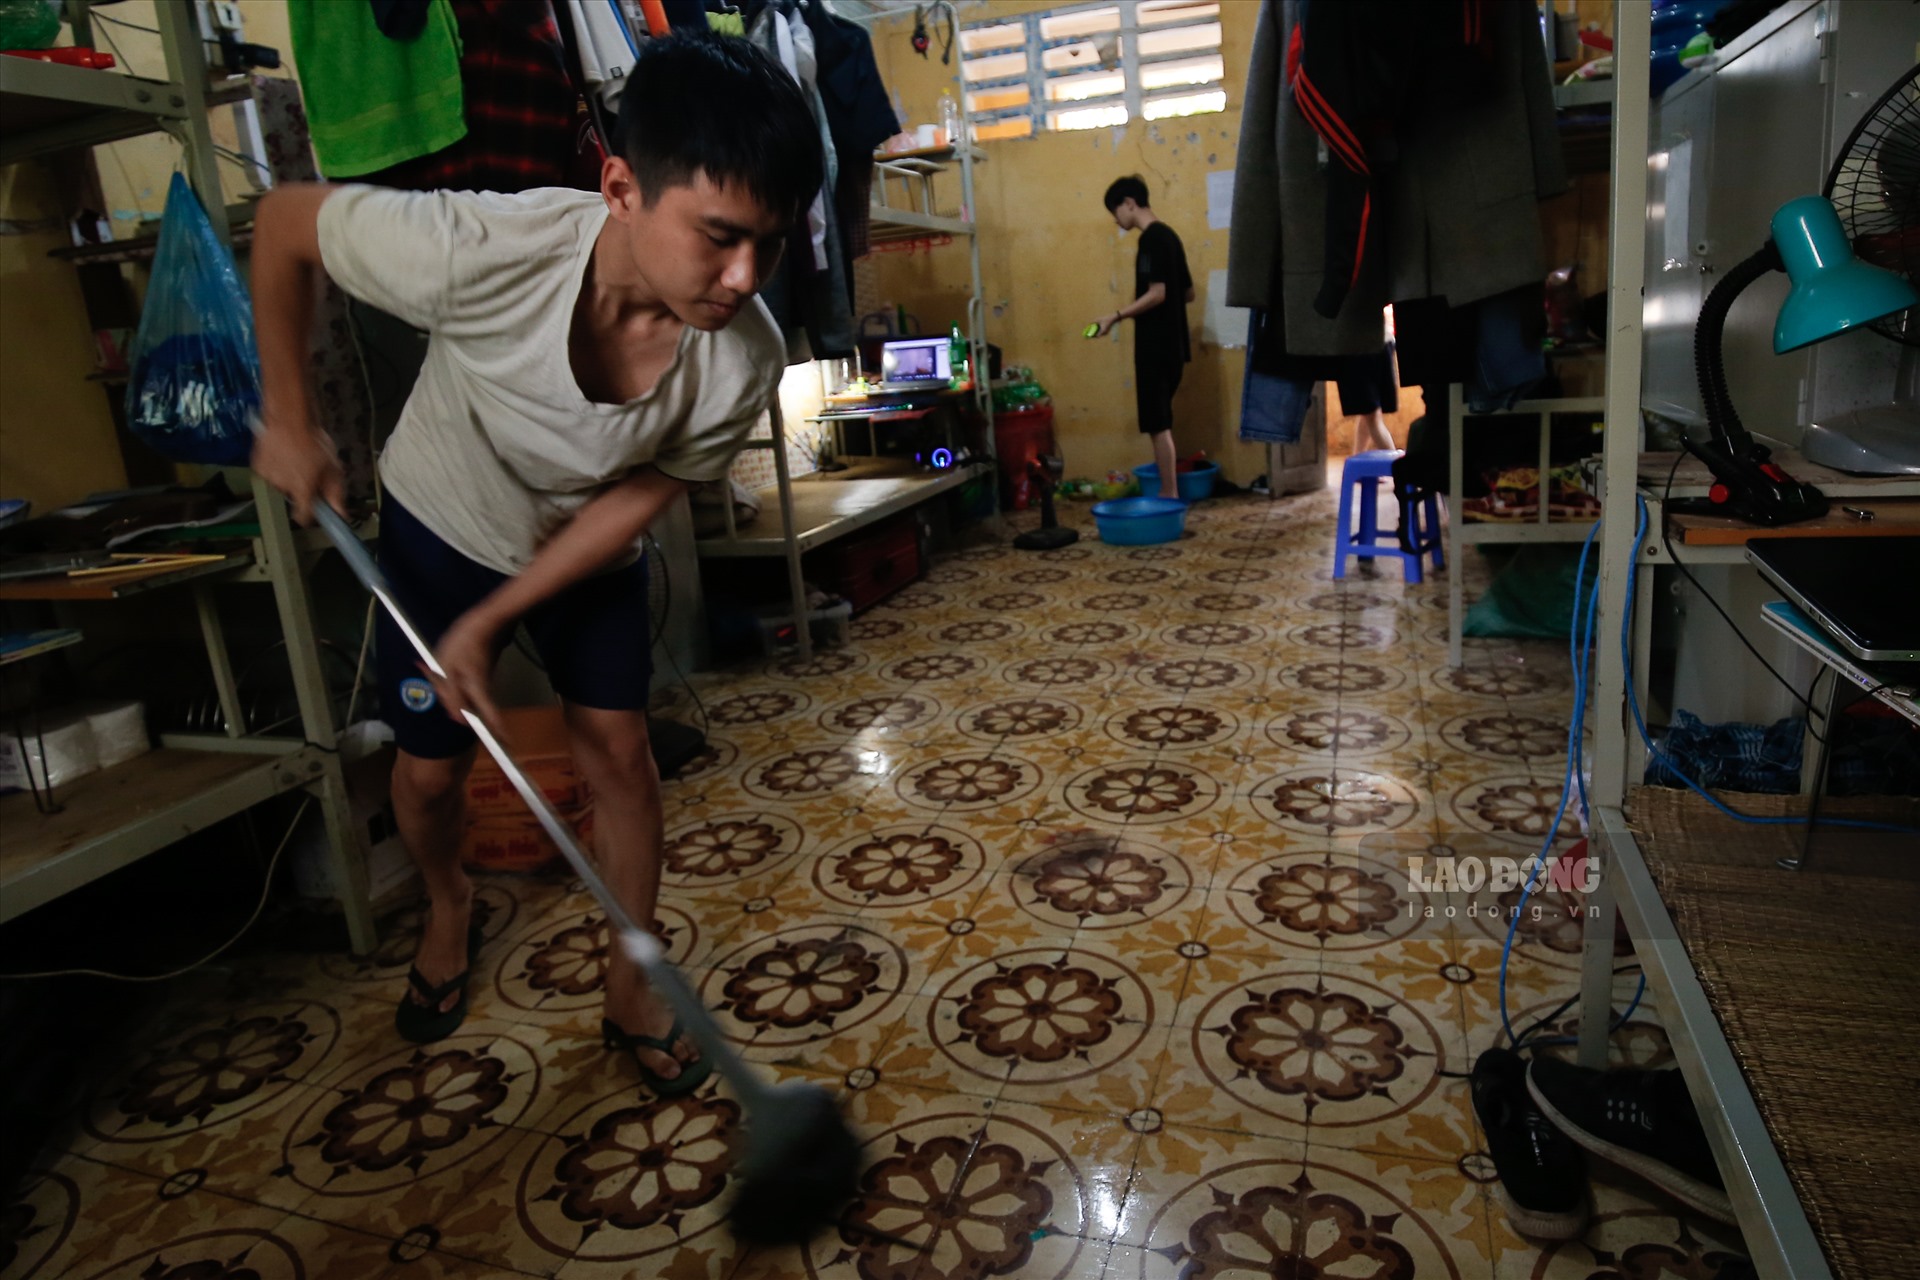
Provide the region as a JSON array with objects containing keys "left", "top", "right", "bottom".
[{"left": 0, "top": 0, "right": 292, "bottom": 510}]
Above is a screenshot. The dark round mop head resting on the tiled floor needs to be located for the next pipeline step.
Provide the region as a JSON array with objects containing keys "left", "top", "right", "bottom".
[{"left": 728, "top": 1084, "right": 860, "bottom": 1244}]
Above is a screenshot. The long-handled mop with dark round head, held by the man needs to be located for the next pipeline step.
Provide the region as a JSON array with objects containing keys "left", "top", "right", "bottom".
[{"left": 315, "top": 501, "right": 860, "bottom": 1244}]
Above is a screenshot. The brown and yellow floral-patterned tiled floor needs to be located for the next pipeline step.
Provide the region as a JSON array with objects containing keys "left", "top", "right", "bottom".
[{"left": 11, "top": 491, "right": 1740, "bottom": 1280}]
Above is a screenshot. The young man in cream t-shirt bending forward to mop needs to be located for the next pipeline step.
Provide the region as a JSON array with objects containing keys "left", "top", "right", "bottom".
[{"left": 253, "top": 35, "right": 826, "bottom": 1094}]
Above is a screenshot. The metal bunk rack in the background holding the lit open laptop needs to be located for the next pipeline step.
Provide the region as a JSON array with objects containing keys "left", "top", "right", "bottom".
[{"left": 697, "top": 0, "right": 993, "bottom": 662}]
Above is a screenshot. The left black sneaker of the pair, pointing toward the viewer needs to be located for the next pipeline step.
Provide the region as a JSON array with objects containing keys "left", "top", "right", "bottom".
[{"left": 1471, "top": 1050, "right": 1588, "bottom": 1240}]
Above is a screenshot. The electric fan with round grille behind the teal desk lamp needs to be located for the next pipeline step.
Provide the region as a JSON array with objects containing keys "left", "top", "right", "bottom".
[{"left": 1801, "top": 65, "right": 1920, "bottom": 476}]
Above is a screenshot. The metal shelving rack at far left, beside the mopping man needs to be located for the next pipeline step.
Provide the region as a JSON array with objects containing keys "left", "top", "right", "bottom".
[{"left": 0, "top": 0, "right": 378, "bottom": 954}]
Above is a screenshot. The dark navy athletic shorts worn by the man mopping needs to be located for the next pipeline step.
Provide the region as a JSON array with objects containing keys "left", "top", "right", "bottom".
[{"left": 374, "top": 495, "right": 653, "bottom": 760}]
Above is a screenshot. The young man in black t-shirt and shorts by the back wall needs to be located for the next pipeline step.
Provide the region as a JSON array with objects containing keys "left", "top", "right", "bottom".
[{"left": 1094, "top": 177, "right": 1194, "bottom": 497}]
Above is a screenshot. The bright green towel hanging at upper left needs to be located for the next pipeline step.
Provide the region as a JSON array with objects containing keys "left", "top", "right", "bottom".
[{"left": 286, "top": 0, "right": 467, "bottom": 178}]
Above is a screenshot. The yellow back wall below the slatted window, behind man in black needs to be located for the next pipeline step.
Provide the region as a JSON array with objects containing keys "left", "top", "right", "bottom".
[{"left": 874, "top": 0, "right": 1267, "bottom": 484}]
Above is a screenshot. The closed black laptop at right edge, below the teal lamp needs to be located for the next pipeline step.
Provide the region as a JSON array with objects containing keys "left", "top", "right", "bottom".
[{"left": 1747, "top": 537, "right": 1920, "bottom": 662}]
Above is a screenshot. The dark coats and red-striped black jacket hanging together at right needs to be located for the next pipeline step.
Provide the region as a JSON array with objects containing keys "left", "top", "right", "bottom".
[{"left": 1227, "top": 0, "right": 1567, "bottom": 355}]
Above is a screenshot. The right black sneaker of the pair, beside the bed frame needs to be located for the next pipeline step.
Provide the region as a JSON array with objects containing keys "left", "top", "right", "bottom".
[{"left": 1526, "top": 1057, "right": 1736, "bottom": 1224}]
